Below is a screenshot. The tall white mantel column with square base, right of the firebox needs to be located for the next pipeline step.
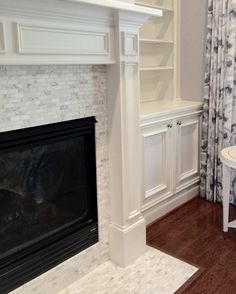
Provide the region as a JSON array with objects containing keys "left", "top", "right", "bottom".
[{"left": 108, "top": 12, "right": 148, "bottom": 266}]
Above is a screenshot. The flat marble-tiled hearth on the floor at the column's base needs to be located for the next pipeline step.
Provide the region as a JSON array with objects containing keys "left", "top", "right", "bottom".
[{"left": 59, "top": 247, "right": 198, "bottom": 294}]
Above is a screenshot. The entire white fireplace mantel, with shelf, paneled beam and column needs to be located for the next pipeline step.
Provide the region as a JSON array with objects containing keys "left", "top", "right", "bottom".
[{"left": 0, "top": 0, "right": 162, "bottom": 266}]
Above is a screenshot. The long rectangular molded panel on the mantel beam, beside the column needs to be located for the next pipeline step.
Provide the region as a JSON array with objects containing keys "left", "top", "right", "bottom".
[{"left": 16, "top": 21, "right": 110, "bottom": 56}]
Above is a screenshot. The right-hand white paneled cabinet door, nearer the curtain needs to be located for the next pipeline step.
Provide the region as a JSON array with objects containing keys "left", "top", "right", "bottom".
[{"left": 176, "top": 117, "right": 199, "bottom": 191}]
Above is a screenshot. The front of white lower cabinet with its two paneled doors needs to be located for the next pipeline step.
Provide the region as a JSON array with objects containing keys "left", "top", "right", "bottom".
[{"left": 141, "top": 109, "right": 201, "bottom": 212}]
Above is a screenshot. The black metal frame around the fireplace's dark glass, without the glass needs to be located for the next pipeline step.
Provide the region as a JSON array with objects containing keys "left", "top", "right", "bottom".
[{"left": 0, "top": 117, "right": 99, "bottom": 294}]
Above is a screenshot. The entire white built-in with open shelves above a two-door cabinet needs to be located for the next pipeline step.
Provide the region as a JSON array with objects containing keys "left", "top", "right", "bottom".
[{"left": 136, "top": 0, "right": 202, "bottom": 223}]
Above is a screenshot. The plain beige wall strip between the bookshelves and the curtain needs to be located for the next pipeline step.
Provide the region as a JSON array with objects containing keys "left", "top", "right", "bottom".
[{"left": 177, "top": 0, "right": 208, "bottom": 101}]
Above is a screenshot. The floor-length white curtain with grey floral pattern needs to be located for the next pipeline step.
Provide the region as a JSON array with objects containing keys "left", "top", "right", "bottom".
[{"left": 200, "top": 0, "right": 236, "bottom": 204}]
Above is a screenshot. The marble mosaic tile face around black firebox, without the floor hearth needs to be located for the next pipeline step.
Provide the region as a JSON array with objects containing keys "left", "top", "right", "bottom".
[{"left": 0, "top": 65, "right": 109, "bottom": 294}]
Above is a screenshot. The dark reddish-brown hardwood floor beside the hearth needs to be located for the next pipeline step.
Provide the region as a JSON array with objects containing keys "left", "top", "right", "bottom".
[{"left": 147, "top": 197, "right": 236, "bottom": 294}]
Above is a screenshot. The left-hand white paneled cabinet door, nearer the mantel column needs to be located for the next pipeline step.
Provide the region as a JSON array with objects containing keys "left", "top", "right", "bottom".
[{"left": 143, "top": 123, "right": 172, "bottom": 209}]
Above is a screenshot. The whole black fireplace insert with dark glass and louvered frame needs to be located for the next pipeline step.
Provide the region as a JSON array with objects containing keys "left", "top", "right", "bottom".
[{"left": 0, "top": 117, "right": 98, "bottom": 294}]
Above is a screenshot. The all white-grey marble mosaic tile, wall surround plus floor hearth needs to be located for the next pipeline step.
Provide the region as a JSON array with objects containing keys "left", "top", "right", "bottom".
[{"left": 0, "top": 65, "right": 197, "bottom": 294}]
